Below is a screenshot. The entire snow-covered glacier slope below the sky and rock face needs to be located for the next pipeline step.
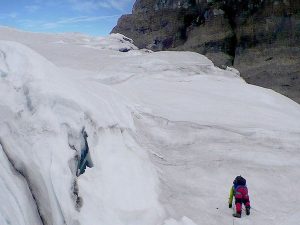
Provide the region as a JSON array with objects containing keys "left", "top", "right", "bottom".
[{"left": 0, "top": 27, "right": 300, "bottom": 225}]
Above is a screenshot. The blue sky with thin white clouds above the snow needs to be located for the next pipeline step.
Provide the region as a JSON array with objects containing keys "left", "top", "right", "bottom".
[{"left": 0, "top": 0, "right": 135, "bottom": 36}]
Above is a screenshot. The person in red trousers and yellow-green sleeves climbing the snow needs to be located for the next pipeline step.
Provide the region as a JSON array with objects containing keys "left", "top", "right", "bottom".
[{"left": 228, "top": 176, "right": 250, "bottom": 218}]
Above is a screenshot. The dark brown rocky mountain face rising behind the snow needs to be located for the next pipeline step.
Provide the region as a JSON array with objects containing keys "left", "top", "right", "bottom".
[{"left": 112, "top": 0, "right": 300, "bottom": 103}]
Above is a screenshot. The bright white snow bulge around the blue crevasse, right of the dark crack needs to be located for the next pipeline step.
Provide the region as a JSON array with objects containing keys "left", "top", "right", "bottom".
[{"left": 0, "top": 42, "right": 162, "bottom": 225}]
